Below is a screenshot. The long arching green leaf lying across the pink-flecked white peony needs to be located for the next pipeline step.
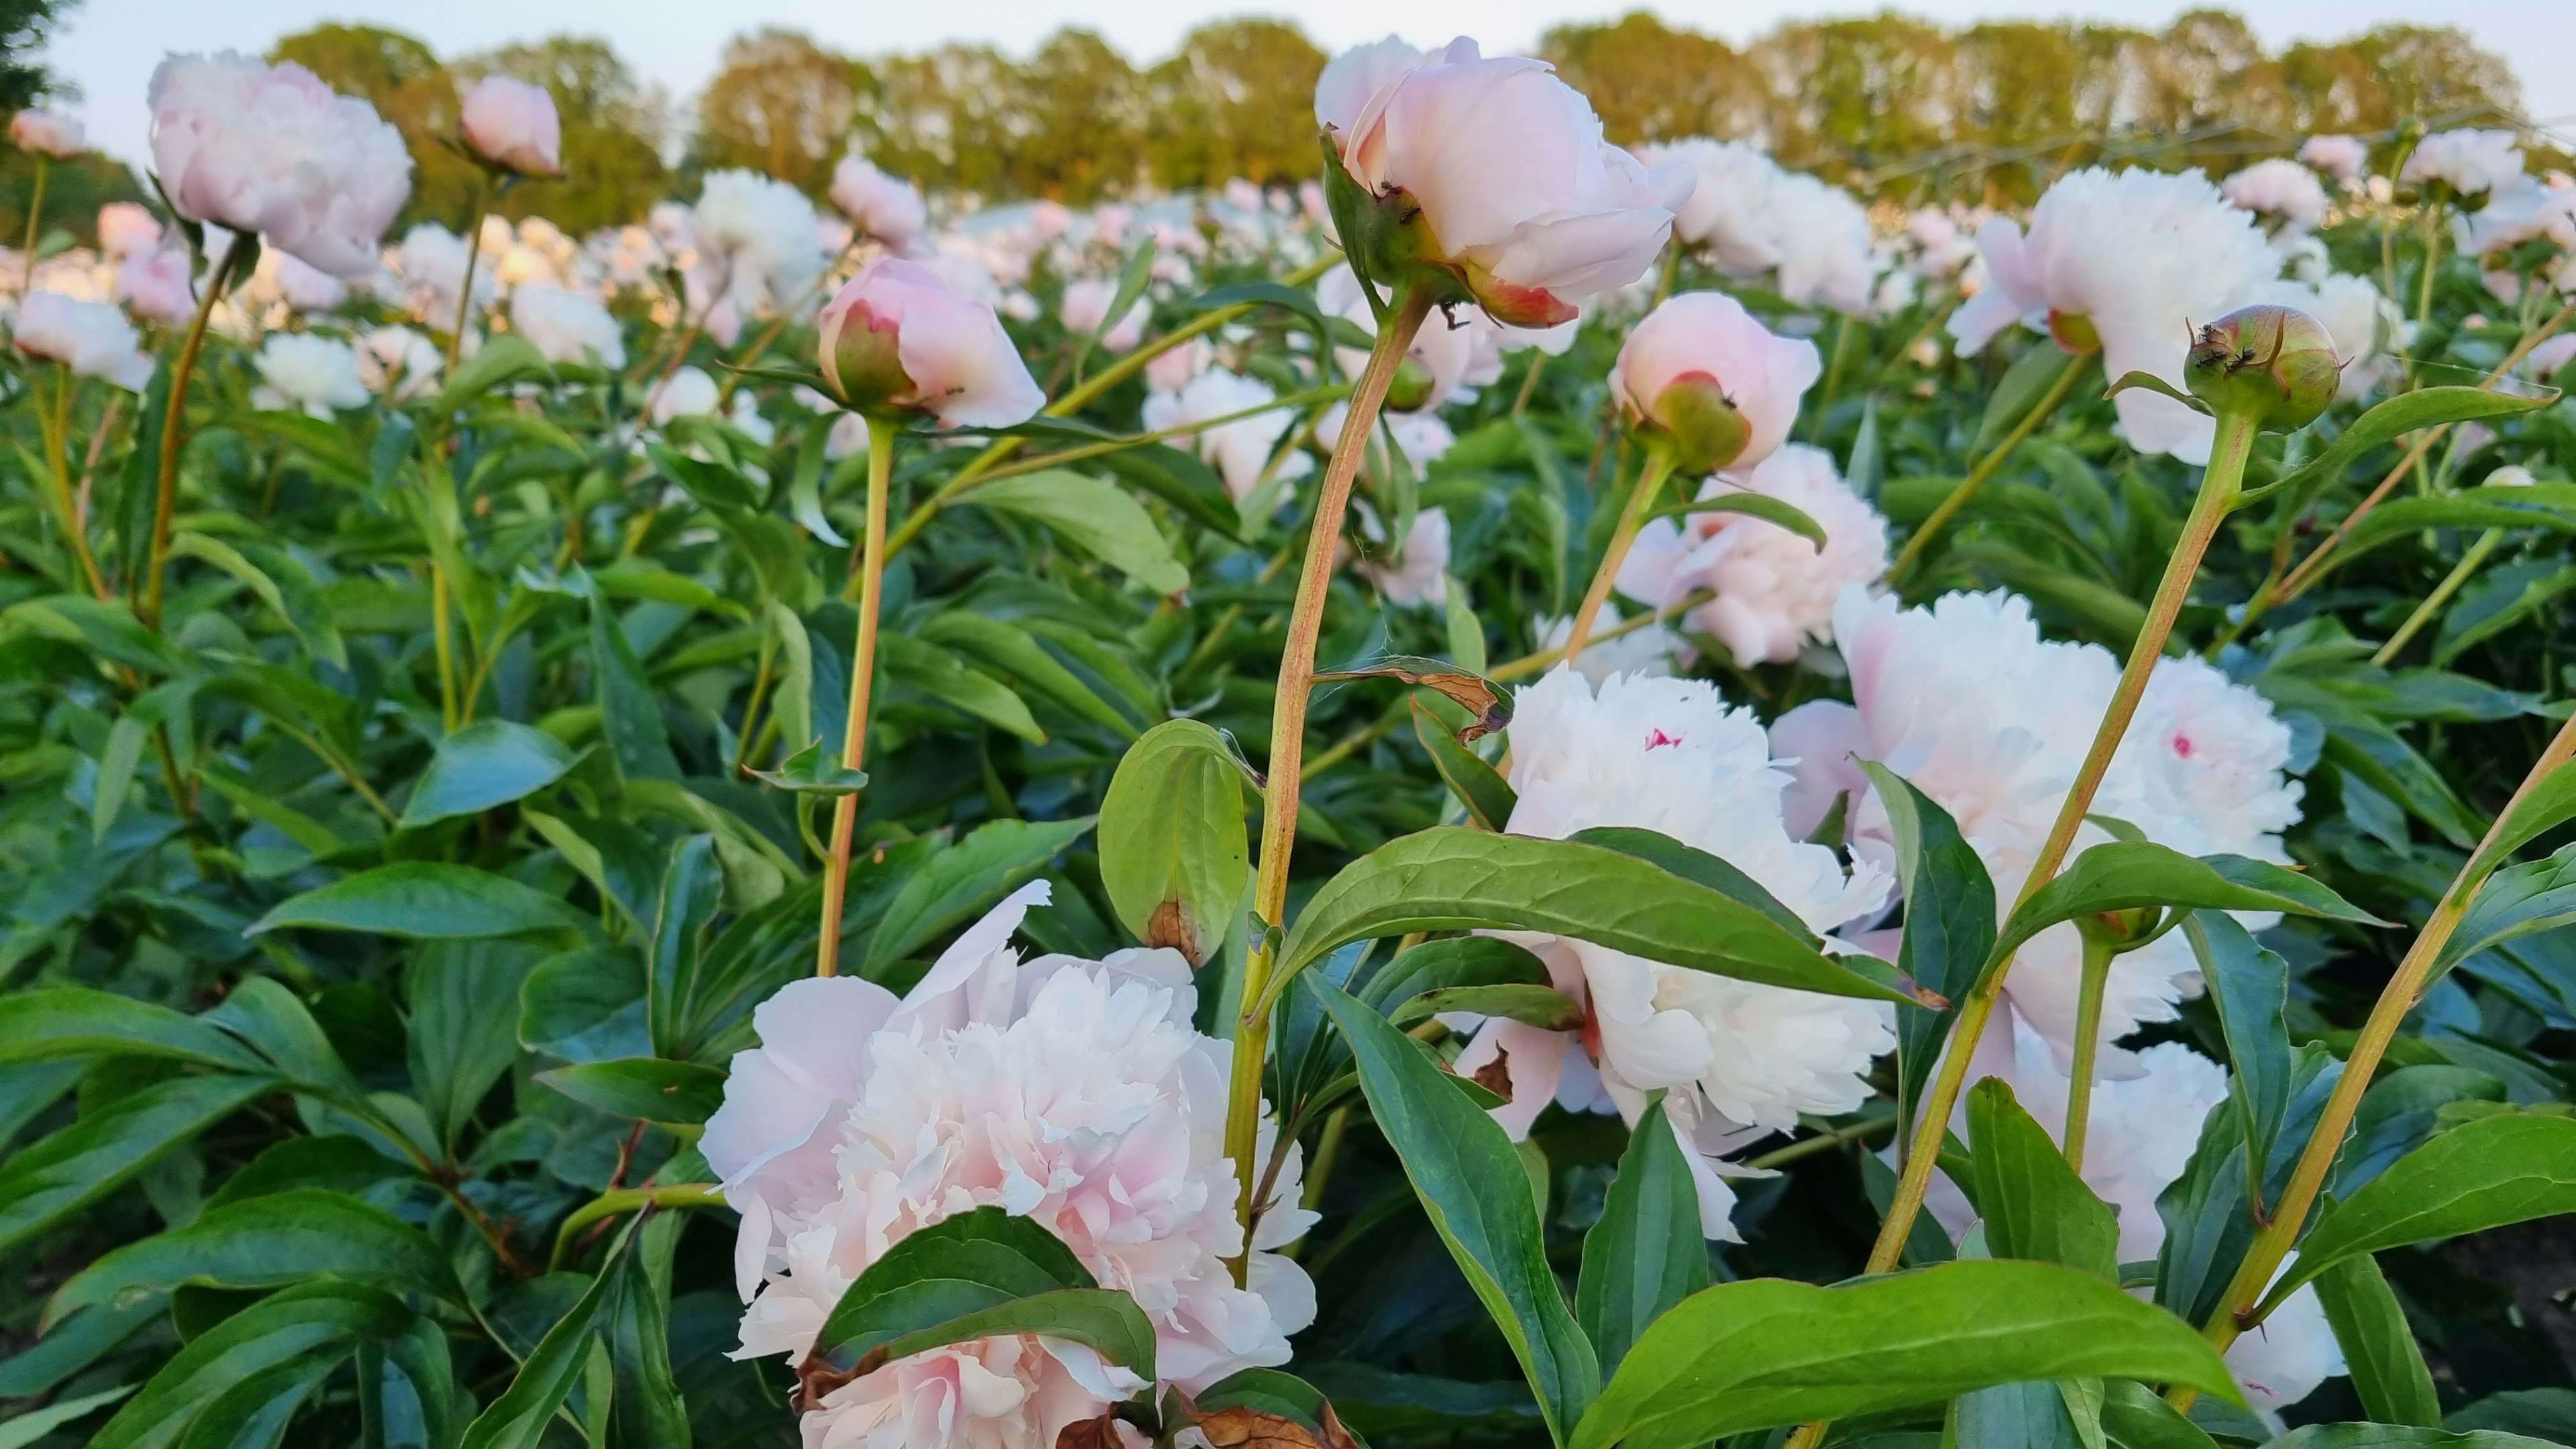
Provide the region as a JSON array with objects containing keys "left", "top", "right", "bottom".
[{"left": 1278, "top": 825, "right": 1909, "bottom": 1000}]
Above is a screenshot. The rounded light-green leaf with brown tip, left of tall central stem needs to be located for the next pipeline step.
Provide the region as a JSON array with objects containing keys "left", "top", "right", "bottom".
[{"left": 1100, "top": 719, "right": 1252, "bottom": 967}]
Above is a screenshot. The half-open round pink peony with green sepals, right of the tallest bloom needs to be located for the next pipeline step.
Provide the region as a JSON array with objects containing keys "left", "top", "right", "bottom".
[{"left": 1610, "top": 291, "right": 1824, "bottom": 472}]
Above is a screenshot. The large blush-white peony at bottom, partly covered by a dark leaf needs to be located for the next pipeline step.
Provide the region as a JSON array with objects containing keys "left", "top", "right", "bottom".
[{"left": 700, "top": 881, "right": 1313, "bottom": 1446}]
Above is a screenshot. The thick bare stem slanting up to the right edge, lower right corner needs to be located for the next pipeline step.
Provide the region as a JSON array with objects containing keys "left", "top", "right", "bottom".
[{"left": 2166, "top": 701, "right": 2576, "bottom": 1408}]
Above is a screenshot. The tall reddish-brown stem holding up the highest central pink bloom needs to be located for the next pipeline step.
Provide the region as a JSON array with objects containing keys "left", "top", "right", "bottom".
[{"left": 1226, "top": 286, "right": 1432, "bottom": 1263}]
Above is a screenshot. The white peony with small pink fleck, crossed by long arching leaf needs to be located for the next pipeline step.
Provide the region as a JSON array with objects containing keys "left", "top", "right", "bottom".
[{"left": 1458, "top": 665, "right": 1896, "bottom": 1240}]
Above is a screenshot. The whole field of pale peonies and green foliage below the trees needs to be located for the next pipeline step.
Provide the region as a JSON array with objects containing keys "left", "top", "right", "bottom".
[{"left": 0, "top": 39, "right": 2576, "bottom": 1449}]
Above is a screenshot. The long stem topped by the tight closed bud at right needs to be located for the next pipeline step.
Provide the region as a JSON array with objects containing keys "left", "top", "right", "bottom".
[{"left": 1785, "top": 413, "right": 2257, "bottom": 1449}]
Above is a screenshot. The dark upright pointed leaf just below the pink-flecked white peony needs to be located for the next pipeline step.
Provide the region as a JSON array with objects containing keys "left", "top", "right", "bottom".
[{"left": 1574, "top": 1091, "right": 1708, "bottom": 1372}]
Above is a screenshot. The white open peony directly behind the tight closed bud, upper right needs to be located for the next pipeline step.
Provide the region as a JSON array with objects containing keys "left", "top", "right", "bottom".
[{"left": 1950, "top": 168, "right": 2279, "bottom": 464}]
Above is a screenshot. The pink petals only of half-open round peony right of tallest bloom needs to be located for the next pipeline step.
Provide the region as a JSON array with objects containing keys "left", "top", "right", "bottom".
[{"left": 1610, "top": 291, "right": 1824, "bottom": 470}]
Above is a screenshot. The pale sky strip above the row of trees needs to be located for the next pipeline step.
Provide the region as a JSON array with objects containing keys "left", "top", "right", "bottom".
[{"left": 49, "top": 0, "right": 2576, "bottom": 160}]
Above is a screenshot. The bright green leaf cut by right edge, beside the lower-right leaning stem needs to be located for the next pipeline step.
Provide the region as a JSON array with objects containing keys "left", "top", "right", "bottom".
[{"left": 2262, "top": 1112, "right": 2576, "bottom": 1312}]
